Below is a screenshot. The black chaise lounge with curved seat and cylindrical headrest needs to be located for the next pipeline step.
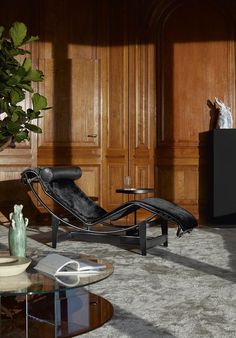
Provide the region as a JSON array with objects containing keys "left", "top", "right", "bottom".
[{"left": 21, "top": 167, "right": 197, "bottom": 255}]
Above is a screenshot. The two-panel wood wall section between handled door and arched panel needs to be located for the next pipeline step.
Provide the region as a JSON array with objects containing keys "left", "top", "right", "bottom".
[{"left": 103, "top": 1, "right": 155, "bottom": 209}]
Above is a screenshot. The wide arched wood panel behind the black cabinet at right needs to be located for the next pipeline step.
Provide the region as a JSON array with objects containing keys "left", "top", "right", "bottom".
[{"left": 156, "top": 1, "right": 235, "bottom": 217}]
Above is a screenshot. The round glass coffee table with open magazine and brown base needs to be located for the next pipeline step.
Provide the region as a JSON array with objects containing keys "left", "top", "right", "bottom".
[{"left": 0, "top": 255, "right": 113, "bottom": 338}]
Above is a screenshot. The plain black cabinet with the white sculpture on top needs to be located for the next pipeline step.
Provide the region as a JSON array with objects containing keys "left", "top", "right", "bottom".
[{"left": 209, "top": 129, "right": 236, "bottom": 224}]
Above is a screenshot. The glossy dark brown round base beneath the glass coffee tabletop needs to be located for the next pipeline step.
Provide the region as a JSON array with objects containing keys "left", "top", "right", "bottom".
[{"left": 0, "top": 288, "right": 113, "bottom": 338}]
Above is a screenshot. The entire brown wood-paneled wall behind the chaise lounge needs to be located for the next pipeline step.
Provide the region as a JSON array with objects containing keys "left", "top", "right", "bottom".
[{"left": 0, "top": 0, "right": 236, "bottom": 222}]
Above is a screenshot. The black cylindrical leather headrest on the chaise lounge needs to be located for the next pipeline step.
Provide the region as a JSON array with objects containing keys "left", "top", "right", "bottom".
[{"left": 39, "top": 167, "right": 82, "bottom": 183}]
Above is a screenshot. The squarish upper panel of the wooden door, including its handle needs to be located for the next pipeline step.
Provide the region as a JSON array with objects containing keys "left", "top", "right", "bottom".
[{"left": 39, "top": 59, "right": 101, "bottom": 147}]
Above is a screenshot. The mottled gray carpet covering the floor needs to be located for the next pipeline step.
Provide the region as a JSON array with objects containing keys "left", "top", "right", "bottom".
[{"left": 0, "top": 227, "right": 236, "bottom": 338}]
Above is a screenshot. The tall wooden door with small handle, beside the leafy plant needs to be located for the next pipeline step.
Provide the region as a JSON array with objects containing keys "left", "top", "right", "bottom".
[{"left": 38, "top": 0, "right": 104, "bottom": 203}]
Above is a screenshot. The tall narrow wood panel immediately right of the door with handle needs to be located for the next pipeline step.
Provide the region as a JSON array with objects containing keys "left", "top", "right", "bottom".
[{"left": 103, "top": 1, "right": 129, "bottom": 209}]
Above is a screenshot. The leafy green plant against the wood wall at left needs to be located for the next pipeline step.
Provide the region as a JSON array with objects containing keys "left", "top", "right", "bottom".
[{"left": 0, "top": 22, "right": 48, "bottom": 150}]
